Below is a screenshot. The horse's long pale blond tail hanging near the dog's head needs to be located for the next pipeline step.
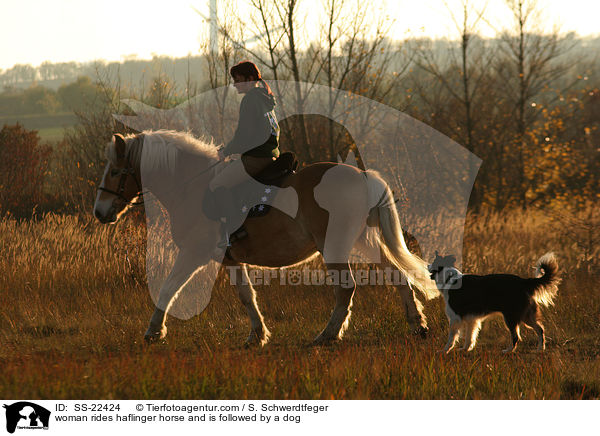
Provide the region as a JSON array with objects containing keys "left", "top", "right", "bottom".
[{"left": 366, "top": 170, "right": 439, "bottom": 299}]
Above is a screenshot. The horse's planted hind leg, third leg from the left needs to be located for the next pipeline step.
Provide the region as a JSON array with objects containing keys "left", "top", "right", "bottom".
[{"left": 314, "top": 263, "right": 356, "bottom": 345}]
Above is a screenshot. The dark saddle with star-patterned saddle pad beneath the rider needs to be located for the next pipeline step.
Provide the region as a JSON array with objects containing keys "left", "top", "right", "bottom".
[{"left": 202, "top": 151, "right": 298, "bottom": 225}]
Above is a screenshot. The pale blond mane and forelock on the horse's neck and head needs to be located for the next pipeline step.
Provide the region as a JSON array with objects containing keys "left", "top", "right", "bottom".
[{"left": 105, "top": 130, "right": 218, "bottom": 173}]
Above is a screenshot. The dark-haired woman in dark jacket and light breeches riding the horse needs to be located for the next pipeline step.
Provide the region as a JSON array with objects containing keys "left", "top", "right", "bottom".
[{"left": 209, "top": 61, "right": 279, "bottom": 246}]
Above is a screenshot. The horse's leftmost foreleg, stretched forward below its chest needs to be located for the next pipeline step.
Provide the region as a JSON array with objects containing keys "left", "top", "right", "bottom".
[{"left": 144, "top": 250, "right": 202, "bottom": 343}]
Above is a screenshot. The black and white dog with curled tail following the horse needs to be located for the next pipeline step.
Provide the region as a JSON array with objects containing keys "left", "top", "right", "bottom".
[{"left": 429, "top": 251, "right": 560, "bottom": 353}]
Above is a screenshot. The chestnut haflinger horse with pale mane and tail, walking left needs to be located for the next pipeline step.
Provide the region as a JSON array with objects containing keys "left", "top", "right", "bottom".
[{"left": 94, "top": 130, "right": 438, "bottom": 345}]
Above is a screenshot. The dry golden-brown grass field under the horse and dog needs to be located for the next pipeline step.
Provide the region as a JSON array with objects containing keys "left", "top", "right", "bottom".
[{"left": 0, "top": 211, "right": 600, "bottom": 399}]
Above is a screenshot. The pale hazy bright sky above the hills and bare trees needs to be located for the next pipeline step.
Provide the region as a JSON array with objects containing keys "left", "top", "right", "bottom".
[{"left": 0, "top": 0, "right": 600, "bottom": 69}]
